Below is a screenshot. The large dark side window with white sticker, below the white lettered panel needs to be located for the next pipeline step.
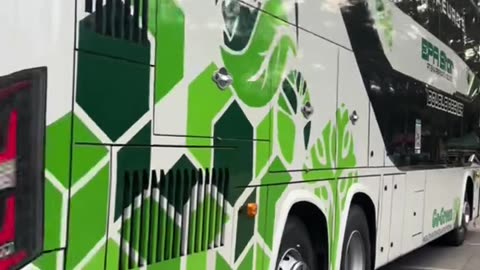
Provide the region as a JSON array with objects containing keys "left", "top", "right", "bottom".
[{"left": 364, "top": 70, "right": 474, "bottom": 167}]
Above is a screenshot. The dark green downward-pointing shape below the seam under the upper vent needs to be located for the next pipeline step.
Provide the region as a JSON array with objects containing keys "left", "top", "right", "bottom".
[{"left": 76, "top": 48, "right": 150, "bottom": 142}]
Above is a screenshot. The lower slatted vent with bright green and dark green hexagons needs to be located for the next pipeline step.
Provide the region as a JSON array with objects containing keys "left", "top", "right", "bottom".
[{"left": 120, "top": 169, "right": 229, "bottom": 269}]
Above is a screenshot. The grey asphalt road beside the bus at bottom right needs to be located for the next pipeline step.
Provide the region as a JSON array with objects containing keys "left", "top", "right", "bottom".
[{"left": 380, "top": 220, "right": 480, "bottom": 270}]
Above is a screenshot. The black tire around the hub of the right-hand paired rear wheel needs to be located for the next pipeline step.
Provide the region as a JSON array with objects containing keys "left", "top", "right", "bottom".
[{"left": 340, "top": 205, "right": 373, "bottom": 270}]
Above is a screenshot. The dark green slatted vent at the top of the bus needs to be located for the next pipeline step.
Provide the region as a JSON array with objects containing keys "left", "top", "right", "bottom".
[{"left": 85, "top": 0, "right": 149, "bottom": 43}]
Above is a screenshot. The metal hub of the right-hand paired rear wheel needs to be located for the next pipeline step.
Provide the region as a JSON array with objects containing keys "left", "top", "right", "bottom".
[{"left": 345, "top": 231, "right": 366, "bottom": 270}]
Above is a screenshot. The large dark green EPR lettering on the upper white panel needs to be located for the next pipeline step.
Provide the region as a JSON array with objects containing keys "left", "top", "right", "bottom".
[{"left": 421, "top": 38, "right": 454, "bottom": 81}]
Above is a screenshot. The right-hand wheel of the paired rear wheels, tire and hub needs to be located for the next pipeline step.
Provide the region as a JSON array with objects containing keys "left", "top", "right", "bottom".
[{"left": 340, "top": 205, "right": 371, "bottom": 270}]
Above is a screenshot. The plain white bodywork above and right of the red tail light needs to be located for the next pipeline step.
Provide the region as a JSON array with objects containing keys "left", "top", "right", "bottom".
[{"left": 0, "top": 0, "right": 75, "bottom": 125}]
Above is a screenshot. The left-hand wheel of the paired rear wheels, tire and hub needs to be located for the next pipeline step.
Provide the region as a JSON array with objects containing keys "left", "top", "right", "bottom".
[{"left": 276, "top": 215, "right": 317, "bottom": 270}]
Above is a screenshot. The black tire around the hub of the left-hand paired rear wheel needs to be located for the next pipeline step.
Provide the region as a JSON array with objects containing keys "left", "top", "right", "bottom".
[{"left": 275, "top": 215, "right": 318, "bottom": 270}]
